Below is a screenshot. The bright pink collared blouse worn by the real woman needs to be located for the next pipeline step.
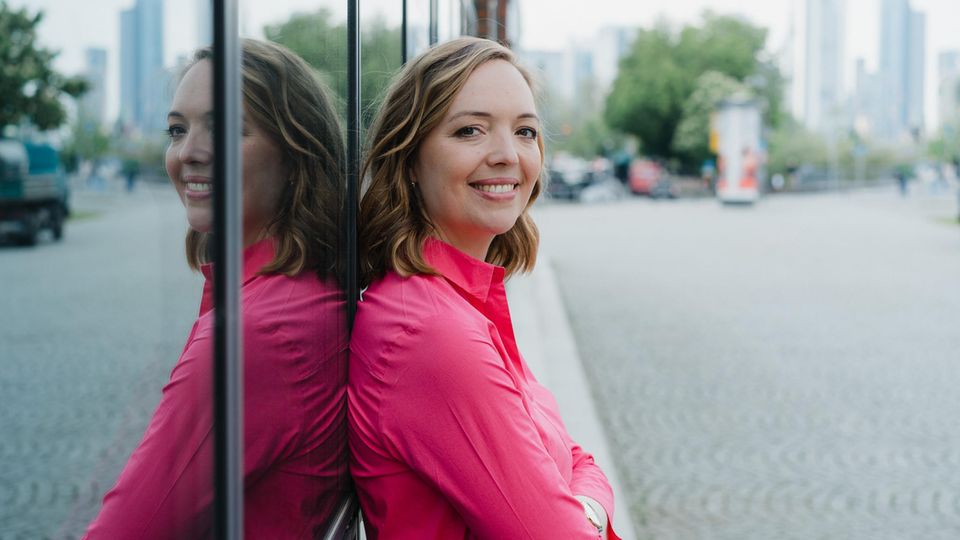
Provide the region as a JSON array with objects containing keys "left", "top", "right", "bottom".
[{"left": 348, "top": 239, "right": 616, "bottom": 540}]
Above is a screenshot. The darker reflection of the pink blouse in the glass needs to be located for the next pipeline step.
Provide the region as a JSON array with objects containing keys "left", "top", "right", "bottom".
[{"left": 87, "top": 240, "right": 349, "bottom": 540}]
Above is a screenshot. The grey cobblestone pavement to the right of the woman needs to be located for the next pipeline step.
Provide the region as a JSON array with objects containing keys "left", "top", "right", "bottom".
[{"left": 535, "top": 185, "right": 960, "bottom": 540}]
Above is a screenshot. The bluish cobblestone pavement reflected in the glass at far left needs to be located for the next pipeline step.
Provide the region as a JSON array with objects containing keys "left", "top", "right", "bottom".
[{"left": 0, "top": 185, "right": 200, "bottom": 540}]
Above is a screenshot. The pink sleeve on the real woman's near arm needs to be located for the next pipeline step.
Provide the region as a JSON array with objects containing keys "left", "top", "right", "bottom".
[{"left": 381, "top": 318, "right": 598, "bottom": 539}]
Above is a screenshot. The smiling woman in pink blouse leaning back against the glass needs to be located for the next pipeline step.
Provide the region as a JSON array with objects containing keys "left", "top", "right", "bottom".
[{"left": 348, "top": 38, "right": 616, "bottom": 539}]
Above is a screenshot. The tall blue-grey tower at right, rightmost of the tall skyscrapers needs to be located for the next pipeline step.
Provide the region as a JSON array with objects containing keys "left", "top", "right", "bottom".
[{"left": 875, "top": 0, "right": 926, "bottom": 139}]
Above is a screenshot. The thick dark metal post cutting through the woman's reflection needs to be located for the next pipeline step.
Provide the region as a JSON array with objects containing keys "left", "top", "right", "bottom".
[{"left": 213, "top": 0, "right": 243, "bottom": 540}]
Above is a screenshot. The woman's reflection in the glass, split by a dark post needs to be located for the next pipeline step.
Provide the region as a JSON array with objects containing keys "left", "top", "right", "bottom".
[{"left": 88, "top": 40, "right": 348, "bottom": 540}]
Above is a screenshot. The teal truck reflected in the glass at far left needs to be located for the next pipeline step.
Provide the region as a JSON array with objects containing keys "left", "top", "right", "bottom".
[{"left": 0, "top": 139, "right": 70, "bottom": 246}]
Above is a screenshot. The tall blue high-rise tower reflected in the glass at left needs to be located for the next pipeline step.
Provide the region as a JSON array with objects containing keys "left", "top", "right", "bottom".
[{"left": 120, "top": 0, "right": 169, "bottom": 132}]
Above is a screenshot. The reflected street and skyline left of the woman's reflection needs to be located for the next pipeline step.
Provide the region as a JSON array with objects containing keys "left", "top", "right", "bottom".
[{"left": 0, "top": 0, "right": 200, "bottom": 538}]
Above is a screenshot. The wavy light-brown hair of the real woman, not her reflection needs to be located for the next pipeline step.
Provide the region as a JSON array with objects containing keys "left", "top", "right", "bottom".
[{"left": 359, "top": 37, "right": 543, "bottom": 285}]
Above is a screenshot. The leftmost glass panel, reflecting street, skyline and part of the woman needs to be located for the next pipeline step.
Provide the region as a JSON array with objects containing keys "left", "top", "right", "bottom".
[{"left": 0, "top": 0, "right": 212, "bottom": 538}]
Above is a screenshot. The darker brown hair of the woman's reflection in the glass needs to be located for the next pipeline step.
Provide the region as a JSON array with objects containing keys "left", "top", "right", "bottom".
[{"left": 184, "top": 39, "right": 346, "bottom": 277}]
